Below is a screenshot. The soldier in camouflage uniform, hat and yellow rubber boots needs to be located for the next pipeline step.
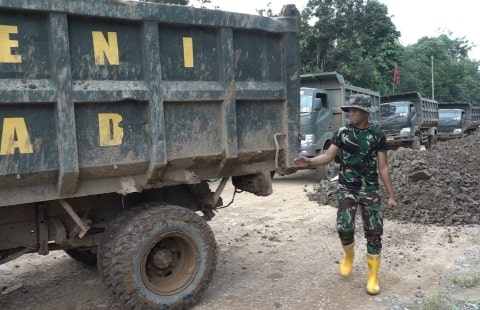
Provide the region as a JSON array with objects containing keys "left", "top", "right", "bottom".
[{"left": 294, "top": 95, "right": 396, "bottom": 295}]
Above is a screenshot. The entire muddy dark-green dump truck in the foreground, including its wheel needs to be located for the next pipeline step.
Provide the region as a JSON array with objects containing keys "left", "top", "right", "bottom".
[{"left": 0, "top": 0, "right": 300, "bottom": 309}]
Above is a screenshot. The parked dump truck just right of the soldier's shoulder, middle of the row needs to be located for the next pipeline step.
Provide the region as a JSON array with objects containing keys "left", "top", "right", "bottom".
[{"left": 380, "top": 92, "right": 439, "bottom": 150}]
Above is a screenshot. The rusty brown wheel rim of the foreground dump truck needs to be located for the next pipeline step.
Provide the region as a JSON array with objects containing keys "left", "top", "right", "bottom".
[{"left": 142, "top": 232, "right": 200, "bottom": 295}]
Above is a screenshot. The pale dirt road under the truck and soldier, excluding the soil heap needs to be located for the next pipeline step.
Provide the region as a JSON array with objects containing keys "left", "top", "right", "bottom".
[{"left": 0, "top": 172, "right": 480, "bottom": 310}]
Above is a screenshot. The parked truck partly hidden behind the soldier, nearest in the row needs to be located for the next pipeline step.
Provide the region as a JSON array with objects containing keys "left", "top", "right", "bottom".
[{"left": 299, "top": 72, "right": 380, "bottom": 180}]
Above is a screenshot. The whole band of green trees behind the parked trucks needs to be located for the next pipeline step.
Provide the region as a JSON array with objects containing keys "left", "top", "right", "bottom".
[{"left": 300, "top": 0, "right": 480, "bottom": 104}]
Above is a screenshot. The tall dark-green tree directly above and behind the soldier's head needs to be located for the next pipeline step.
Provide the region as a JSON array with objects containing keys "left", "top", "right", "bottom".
[{"left": 300, "top": 0, "right": 402, "bottom": 92}]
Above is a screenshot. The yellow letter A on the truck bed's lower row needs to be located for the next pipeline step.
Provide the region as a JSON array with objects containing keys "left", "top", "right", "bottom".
[{"left": 0, "top": 117, "right": 33, "bottom": 155}]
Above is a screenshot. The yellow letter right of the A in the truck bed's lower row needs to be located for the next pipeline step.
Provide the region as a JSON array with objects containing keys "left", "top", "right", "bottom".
[{"left": 98, "top": 113, "right": 123, "bottom": 146}]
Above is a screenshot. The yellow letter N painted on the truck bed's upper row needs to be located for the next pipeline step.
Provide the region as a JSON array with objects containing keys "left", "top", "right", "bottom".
[{"left": 92, "top": 31, "right": 120, "bottom": 65}]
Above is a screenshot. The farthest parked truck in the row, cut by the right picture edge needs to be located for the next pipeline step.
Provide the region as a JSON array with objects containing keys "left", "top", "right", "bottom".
[{"left": 438, "top": 102, "right": 480, "bottom": 140}]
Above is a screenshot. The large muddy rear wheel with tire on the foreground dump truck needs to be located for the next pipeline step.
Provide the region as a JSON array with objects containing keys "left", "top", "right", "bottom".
[{"left": 102, "top": 204, "right": 217, "bottom": 309}]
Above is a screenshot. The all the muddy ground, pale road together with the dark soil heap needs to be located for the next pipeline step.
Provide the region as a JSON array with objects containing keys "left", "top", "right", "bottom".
[{"left": 0, "top": 136, "right": 480, "bottom": 310}]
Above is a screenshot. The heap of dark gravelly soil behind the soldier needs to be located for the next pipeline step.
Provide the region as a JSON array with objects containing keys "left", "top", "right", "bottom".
[{"left": 307, "top": 135, "right": 480, "bottom": 226}]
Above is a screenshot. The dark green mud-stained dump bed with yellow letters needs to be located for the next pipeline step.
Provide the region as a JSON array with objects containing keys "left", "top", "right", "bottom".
[{"left": 0, "top": 0, "right": 300, "bottom": 206}]
